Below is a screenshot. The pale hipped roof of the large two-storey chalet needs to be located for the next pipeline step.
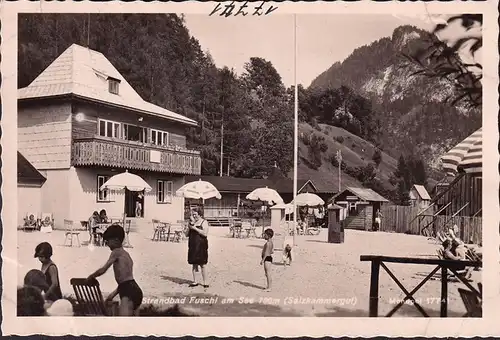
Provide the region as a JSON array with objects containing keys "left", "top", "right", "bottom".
[{"left": 18, "top": 44, "right": 197, "bottom": 125}]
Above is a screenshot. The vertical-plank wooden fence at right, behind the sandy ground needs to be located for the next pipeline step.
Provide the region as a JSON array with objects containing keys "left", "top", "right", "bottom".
[{"left": 380, "top": 205, "right": 483, "bottom": 244}]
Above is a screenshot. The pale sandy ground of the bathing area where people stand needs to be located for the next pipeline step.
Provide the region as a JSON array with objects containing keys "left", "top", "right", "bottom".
[{"left": 17, "top": 223, "right": 481, "bottom": 317}]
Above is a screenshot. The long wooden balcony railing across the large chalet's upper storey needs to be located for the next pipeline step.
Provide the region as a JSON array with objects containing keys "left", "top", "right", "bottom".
[{"left": 71, "top": 136, "right": 201, "bottom": 175}]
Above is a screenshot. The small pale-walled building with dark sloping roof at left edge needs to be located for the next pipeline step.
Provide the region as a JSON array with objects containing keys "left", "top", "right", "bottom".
[{"left": 17, "top": 152, "right": 46, "bottom": 226}]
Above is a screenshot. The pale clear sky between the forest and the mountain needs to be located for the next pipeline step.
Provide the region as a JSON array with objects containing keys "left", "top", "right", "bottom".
[{"left": 185, "top": 14, "right": 439, "bottom": 87}]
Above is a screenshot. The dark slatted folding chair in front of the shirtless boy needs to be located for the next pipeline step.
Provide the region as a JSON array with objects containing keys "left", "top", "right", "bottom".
[{"left": 70, "top": 278, "right": 118, "bottom": 316}]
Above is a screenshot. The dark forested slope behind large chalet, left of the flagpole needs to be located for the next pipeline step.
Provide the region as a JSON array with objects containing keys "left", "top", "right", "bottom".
[{"left": 18, "top": 14, "right": 293, "bottom": 177}]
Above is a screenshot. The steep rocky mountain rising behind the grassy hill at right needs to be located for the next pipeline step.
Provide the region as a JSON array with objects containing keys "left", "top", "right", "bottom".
[{"left": 307, "top": 26, "right": 481, "bottom": 178}]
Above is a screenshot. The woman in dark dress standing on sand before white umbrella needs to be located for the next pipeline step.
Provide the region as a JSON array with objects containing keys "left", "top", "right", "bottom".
[{"left": 186, "top": 208, "right": 209, "bottom": 288}]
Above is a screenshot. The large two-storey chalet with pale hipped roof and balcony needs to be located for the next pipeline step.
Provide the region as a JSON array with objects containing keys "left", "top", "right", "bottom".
[{"left": 18, "top": 44, "right": 201, "bottom": 227}]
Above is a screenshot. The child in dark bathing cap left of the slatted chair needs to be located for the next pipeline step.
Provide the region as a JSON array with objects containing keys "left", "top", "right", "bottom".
[{"left": 35, "top": 242, "right": 62, "bottom": 302}]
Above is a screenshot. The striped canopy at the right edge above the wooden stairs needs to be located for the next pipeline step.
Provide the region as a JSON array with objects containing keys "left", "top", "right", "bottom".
[{"left": 441, "top": 128, "right": 483, "bottom": 175}]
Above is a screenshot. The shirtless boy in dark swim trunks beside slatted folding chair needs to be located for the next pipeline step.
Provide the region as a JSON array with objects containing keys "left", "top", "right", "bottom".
[{"left": 87, "top": 224, "right": 143, "bottom": 316}]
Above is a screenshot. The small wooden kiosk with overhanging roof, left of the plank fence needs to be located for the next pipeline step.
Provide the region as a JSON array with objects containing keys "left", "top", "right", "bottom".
[{"left": 332, "top": 187, "right": 389, "bottom": 230}]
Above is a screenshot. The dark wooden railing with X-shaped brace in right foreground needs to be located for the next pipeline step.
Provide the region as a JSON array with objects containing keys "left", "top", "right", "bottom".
[{"left": 360, "top": 255, "right": 482, "bottom": 317}]
